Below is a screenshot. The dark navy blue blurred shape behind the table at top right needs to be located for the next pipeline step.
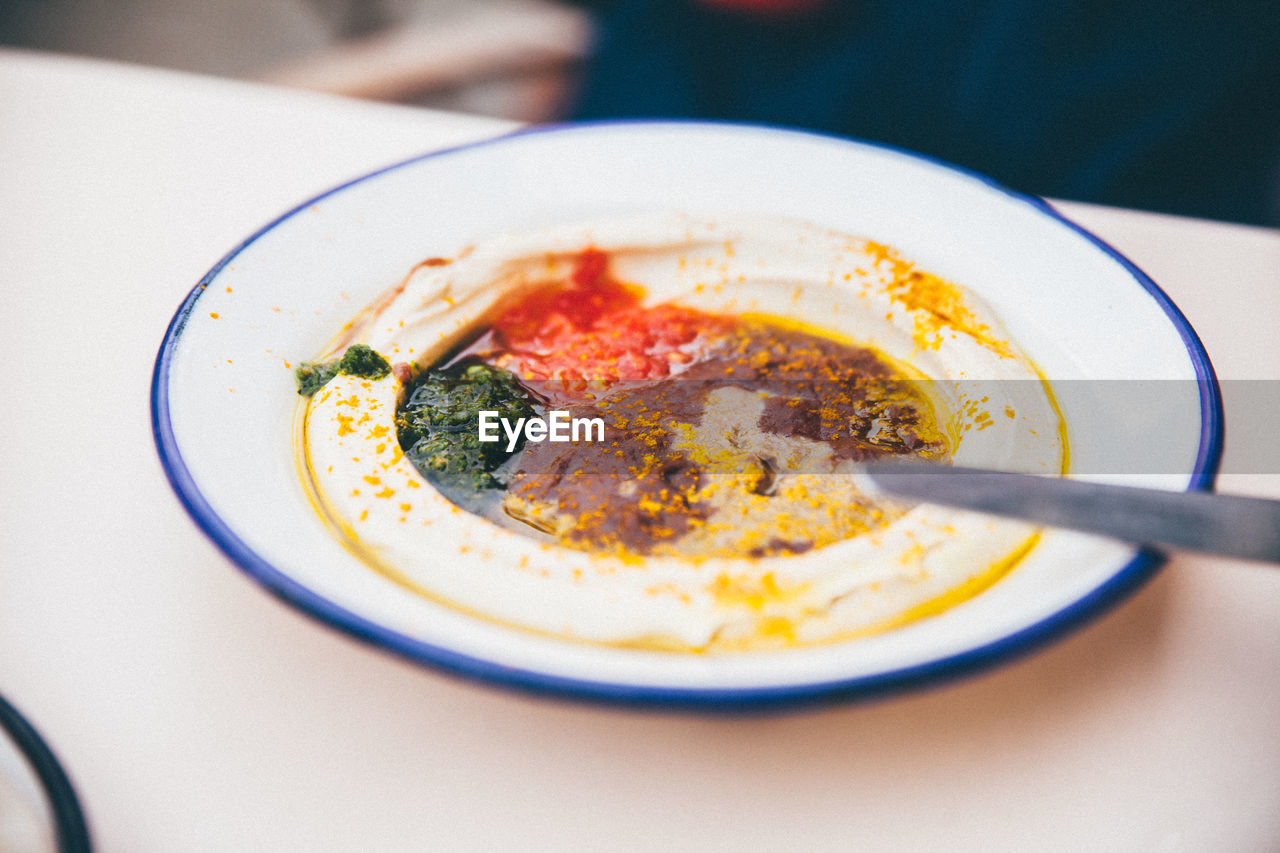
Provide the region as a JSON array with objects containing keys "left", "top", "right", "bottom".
[{"left": 572, "top": 0, "right": 1280, "bottom": 225}]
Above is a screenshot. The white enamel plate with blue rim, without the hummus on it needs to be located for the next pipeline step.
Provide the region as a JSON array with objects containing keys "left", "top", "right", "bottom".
[{"left": 152, "top": 117, "right": 1221, "bottom": 708}]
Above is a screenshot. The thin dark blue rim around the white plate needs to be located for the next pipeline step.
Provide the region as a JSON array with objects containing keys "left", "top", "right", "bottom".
[{"left": 151, "top": 119, "right": 1224, "bottom": 712}]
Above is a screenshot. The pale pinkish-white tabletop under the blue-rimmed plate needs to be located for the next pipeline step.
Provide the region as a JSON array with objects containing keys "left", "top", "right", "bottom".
[{"left": 0, "top": 51, "right": 1280, "bottom": 853}]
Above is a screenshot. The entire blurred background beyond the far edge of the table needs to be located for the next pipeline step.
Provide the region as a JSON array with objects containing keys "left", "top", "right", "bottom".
[{"left": 0, "top": 0, "right": 1280, "bottom": 227}]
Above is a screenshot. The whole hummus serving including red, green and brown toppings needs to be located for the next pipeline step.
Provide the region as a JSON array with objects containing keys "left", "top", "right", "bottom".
[{"left": 301, "top": 215, "right": 1065, "bottom": 649}]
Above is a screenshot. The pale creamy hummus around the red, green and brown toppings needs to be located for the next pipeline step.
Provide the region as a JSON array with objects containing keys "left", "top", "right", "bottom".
[{"left": 301, "top": 215, "right": 1066, "bottom": 651}]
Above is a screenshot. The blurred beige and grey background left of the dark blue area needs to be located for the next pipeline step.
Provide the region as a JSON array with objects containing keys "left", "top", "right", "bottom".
[{"left": 0, "top": 0, "right": 589, "bottom": 122}]
